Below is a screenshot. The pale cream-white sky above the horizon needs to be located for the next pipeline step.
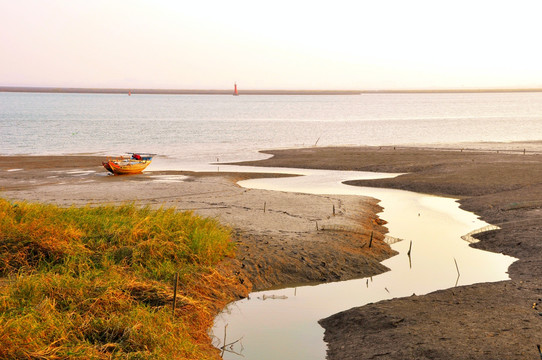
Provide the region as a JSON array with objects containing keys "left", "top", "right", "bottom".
[{"left": 0, "top": 0, "right": 542, "bottom": 90}]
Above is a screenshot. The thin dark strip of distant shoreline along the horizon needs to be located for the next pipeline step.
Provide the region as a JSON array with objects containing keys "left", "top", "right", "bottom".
[{"left": 0, "top": 86, "right": 542, "bottom": 95}]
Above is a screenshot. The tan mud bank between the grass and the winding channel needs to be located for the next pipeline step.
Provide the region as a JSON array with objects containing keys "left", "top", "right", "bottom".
[{"left": 0, "top": 156, "right": 394, "bottom": 290}]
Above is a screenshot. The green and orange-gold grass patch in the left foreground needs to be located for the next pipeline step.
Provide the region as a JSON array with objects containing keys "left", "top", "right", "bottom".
[{"left": 0, "top": 198, "right": 244, "bottom": 359}]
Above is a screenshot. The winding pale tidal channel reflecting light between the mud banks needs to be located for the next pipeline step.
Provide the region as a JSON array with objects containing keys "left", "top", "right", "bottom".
[{"left": 212, "top": 169, "right": 516, "bottom": 360}]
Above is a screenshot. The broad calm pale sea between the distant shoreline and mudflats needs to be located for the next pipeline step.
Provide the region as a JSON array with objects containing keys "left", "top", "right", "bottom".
[{"left": 0, "top": 93, "right": 542, "bottom": 162}]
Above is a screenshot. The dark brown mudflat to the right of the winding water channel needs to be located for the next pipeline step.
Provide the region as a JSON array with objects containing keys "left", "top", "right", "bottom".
[{"left": 243, "top": 144, "right": 542, "bottom": 359}]
